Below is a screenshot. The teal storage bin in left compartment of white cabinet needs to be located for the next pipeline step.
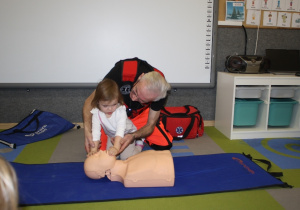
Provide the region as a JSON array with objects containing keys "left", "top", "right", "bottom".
[{"left": 233, "top": 98, "right": 263, "bottom": 126}]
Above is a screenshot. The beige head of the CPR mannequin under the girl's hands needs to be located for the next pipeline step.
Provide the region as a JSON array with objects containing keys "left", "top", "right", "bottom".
[{"left": 84, "top": 150, "right": 116, "bottom": 179}]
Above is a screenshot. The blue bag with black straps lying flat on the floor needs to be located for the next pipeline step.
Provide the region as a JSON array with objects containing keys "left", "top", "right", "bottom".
[{"left": 0, "top": 109, "right": 78, "bottom": 148}]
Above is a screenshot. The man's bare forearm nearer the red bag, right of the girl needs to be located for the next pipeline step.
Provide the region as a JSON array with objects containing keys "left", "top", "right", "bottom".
[{"left": 119, "top": 108, "right": 160, "bottom": 153}]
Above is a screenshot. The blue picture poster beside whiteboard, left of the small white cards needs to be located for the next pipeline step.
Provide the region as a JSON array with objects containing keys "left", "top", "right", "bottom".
[{"left": 225, "top": 1, "right": 245, "bottom": 22}]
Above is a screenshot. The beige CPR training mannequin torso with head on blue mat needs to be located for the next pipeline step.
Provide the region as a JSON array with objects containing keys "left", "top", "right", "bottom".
[{"left": 84, "top": 150, "right": 175, "bottom": 187}]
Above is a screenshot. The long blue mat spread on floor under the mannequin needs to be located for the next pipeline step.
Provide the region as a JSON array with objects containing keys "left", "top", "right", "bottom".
[{"left": 12, "top": 153, "right": 286, "bottom": 206}]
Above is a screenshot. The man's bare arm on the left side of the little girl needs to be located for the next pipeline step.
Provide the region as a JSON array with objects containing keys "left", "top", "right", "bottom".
[{"left": 82, "top": 91, "right": 95, "bottom": 153}]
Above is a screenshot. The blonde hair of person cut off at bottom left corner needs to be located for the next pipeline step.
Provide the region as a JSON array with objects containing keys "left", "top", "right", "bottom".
[{"left": 0, "top": 156, "right": 19, "bottom": 210}]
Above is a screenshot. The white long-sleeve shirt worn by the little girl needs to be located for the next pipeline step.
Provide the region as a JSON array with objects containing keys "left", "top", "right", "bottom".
[{"left": 91, "top": 105, "right": 137, "bottom": 141}]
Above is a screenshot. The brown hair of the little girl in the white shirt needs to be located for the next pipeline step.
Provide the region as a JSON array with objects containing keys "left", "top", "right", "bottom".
[{"left": 91, "top": 79, "right": 124, "bottom": 108}]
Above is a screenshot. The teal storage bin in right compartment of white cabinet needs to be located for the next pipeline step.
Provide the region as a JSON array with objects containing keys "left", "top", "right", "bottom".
[{"left": 268, "top": 98, "right": 298, "bottom": 127}]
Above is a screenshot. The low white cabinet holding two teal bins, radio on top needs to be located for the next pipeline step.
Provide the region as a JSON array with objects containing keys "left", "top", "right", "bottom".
[{"left": 215, "top": 72, "right": 300, "bottom": 139}]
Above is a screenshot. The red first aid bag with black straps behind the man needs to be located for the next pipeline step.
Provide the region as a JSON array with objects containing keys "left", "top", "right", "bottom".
[{"left": 160, "top": 105, "right": 204, "bottom": 140}]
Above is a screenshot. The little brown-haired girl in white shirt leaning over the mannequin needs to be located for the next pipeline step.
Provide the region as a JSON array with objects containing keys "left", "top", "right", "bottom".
[{"left": 88, "top": 79, "right": 143, "bottom": 160}]
